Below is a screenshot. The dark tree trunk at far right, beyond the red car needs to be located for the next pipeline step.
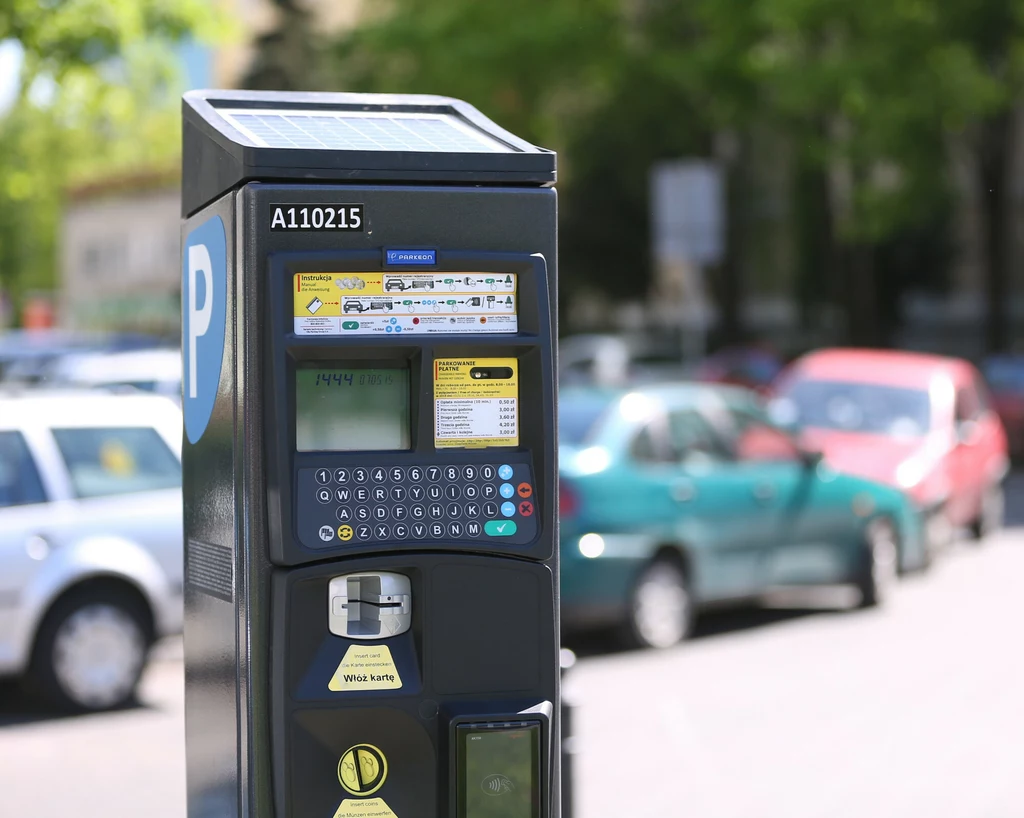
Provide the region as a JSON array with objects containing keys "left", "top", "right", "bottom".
[{"left": 978, "top": 111, "right": 1015, "bottom": 353}]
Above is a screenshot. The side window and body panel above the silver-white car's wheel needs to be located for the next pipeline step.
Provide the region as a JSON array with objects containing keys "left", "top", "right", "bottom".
[{"left": 51, "top": 426, "right": 182, "bottom": 590}]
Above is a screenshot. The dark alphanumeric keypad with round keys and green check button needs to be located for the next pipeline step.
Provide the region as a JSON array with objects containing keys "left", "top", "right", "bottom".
[{"left": 296, "top": 463, "right": 538, "bottom": 548}]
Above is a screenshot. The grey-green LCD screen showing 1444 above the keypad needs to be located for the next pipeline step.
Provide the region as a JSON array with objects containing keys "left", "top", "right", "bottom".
[{"left": 295, "top": 367, "right": 411, "bottom": 451}]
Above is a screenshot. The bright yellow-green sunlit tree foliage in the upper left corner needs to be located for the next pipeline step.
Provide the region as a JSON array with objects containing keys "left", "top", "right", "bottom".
[{"left": 0, "top": 0, "right": 221, "bottom": 325}]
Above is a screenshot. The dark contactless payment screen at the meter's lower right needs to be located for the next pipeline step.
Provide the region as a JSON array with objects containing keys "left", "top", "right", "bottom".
[{"left": 457, "top": 722, "right": 541, "bottom": 818}]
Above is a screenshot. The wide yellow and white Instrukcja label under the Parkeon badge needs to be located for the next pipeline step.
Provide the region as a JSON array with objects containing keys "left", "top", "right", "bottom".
[{"left": 293, "top": 272, "right": 519, "bottom": 335}]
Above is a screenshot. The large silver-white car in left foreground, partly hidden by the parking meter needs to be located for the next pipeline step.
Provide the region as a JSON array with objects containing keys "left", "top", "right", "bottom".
[{"left": 0, "top": 391, "right": 183, "bottom": 711}]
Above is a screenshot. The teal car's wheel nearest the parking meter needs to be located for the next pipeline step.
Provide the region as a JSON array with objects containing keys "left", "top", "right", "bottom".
[{"left": 625, "top": 559, "right": 693, "bottom": 648}]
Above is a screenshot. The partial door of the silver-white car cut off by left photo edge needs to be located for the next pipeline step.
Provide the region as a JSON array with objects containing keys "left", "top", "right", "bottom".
[{"left": 0, "top": 430, "right": 48, "bottom": 671}]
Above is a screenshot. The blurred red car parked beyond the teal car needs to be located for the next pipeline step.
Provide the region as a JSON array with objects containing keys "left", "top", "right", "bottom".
[{"left": 772, "top": 349, "right": 1010, "bottom": 548}]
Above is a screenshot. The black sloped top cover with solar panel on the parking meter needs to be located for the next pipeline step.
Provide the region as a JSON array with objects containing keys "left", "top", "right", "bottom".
[{"left": 181, "top": 91, "right": 555, "bottom": 216}]
